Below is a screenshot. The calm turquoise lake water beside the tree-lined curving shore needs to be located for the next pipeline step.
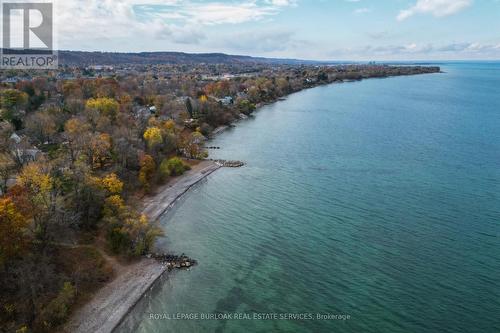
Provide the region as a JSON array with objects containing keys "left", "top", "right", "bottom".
[{"left": 118, "top": 63, "right": 500, "bottom": 333}]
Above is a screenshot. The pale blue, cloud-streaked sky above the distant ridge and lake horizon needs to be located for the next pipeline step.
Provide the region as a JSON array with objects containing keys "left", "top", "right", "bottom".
[{"left": 49, "top": 0, "right": 500, "bottom": 61}]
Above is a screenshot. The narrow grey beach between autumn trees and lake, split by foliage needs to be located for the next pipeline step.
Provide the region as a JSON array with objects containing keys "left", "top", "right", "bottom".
[{"left": 64, "top": 161, "right": 220, "bottom": 333}]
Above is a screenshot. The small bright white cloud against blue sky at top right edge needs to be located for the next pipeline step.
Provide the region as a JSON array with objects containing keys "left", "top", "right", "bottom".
[{"left": 397, "top": 0, "right": 472, "bottom": 21}]
